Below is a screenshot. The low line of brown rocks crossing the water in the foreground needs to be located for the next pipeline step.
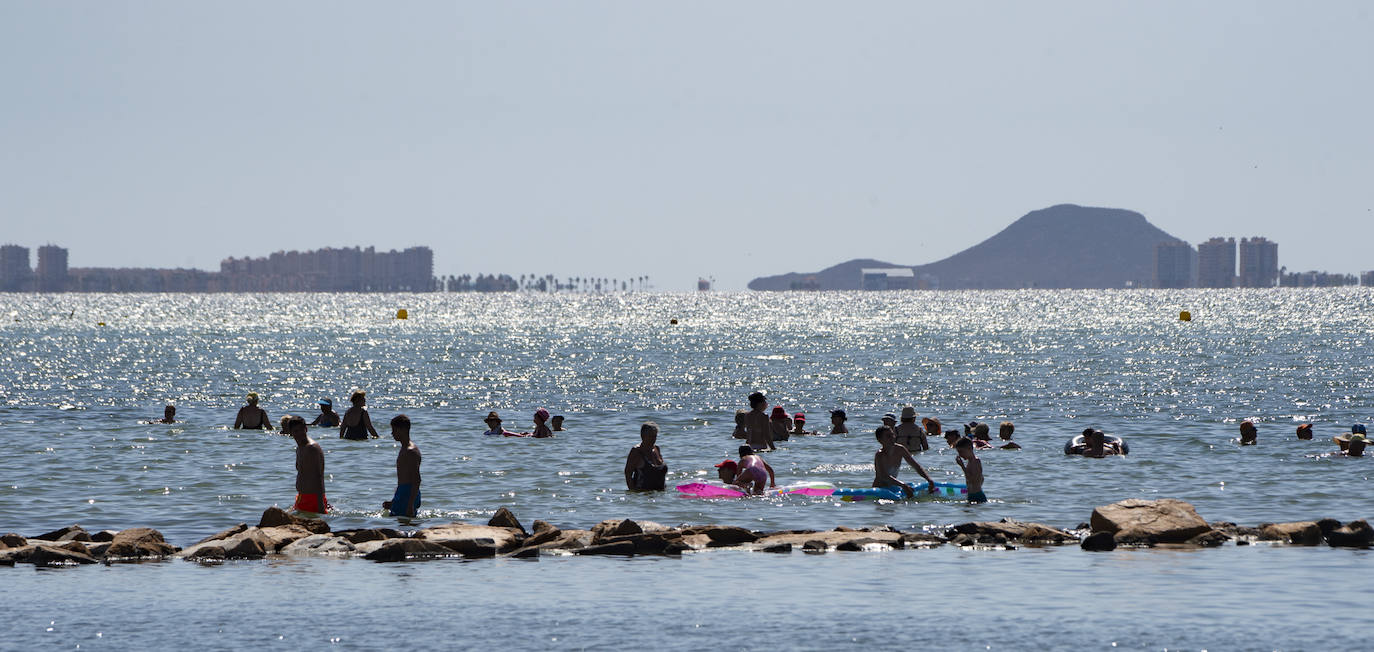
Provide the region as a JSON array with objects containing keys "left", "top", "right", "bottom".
[{"left": 0, "top": 498, "right": 1374, "bottom": 566}]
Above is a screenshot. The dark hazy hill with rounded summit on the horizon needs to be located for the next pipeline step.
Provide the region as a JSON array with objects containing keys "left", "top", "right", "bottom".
[{"left": 749, "top": 205, "right": 1179, "bottom": 290}]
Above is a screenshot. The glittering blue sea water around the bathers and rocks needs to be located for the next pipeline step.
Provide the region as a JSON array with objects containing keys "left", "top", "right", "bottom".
[{"left": 0, "top": 288, "right": 1374, "bottom": 649}]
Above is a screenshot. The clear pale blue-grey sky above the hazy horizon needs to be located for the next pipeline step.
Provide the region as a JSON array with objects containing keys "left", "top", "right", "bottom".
[{"left": 0, "top": 0, "right": 1374, "bottom": 290}]
